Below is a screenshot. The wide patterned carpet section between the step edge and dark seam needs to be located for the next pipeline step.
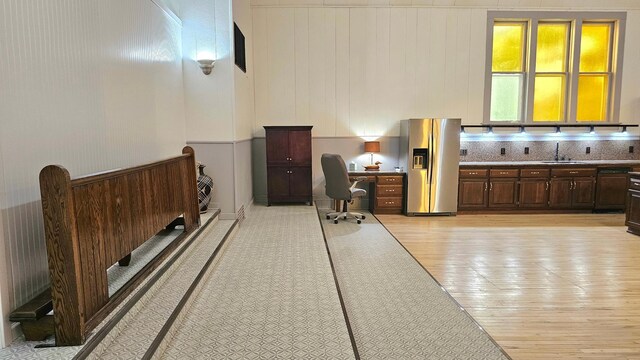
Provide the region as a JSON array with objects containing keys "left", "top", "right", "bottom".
[{"left": 159, "top": 205, "right": 354, "bottom": 359}]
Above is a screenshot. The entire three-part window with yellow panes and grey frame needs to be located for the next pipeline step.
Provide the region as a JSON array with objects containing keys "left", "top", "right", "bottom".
[{"left": 485, "top": 12, "right": 626, "bottom": 123}]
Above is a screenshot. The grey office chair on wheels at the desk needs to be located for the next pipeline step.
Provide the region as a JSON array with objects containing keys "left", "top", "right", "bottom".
[{"left": 320, "top": 154, "right": 367, "bottom": 224}]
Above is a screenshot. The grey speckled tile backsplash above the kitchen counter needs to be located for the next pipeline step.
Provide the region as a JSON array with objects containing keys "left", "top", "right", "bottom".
[{"left": 460, "top": 140, "right": 640, "bottom": 162}]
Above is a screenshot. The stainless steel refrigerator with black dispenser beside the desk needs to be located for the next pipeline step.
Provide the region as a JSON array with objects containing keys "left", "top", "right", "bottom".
[{"left": 400, "top": 119, "right": 462, "bottom": 215}]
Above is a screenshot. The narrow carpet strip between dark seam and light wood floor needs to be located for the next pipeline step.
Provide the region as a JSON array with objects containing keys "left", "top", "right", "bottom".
[{"left": 320, "top": 208, "right": 507, "bottom": 360}]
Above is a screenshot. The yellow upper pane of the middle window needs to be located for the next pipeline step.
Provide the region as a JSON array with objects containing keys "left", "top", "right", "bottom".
[{"left": 536, "top": 23, "right": 569, "bottom": 72}]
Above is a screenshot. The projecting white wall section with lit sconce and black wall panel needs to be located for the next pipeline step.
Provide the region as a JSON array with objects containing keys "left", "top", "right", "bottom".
[{"left": 180, "top": 0, "right": 254, "bottom": 218}]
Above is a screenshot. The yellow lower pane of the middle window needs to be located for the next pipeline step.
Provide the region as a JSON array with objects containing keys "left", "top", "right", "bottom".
[{"left": 533, "top": 75, "right": 565, "bottom": 121}]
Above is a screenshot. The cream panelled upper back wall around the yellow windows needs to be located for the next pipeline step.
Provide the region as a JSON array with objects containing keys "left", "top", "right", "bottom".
[{"left": 253, "top": 0, "right": 640, "bottom": 137}]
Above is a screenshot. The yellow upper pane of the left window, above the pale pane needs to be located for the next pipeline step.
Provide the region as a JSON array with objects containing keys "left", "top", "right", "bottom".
[{"left": 491, "top": 23, "right": 525, "bottom": 72}]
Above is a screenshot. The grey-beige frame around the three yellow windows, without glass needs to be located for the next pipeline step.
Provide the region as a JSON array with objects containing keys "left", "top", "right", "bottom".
[{"left": 483, "top": 11, "right": 627, "bottom": 126}]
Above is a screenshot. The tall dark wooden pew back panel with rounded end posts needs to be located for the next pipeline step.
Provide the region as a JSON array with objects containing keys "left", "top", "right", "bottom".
[{"left": 35, "top": 146, "right": 200, "bottom": 346}]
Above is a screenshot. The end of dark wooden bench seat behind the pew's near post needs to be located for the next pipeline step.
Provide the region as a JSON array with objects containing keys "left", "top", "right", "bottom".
[{"left": 9, "top": 288, "right": 55, "bottom": 341}]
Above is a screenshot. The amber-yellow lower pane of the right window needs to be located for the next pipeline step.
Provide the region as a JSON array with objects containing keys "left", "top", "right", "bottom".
[{"left": 576, "top": 75, "right": 609, "bottom": 121}]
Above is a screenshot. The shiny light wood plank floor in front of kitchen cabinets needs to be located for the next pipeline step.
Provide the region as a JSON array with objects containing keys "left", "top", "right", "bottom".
[{"left": 377, "top": 214, "right": 640, "bottom": 360}]
